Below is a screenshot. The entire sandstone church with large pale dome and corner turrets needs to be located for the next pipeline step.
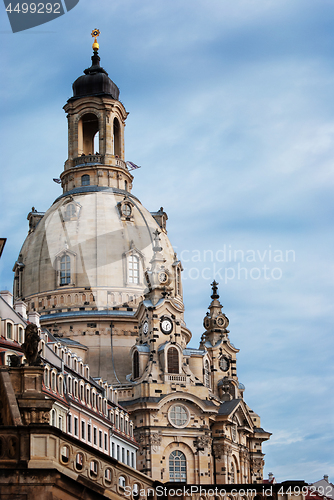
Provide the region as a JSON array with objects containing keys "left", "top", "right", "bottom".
[{"left": 13, "top": 30, "right": 270, "bottom": 485}]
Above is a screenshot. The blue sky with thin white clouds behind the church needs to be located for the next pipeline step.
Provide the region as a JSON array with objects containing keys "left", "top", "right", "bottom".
[{"left": 0, "top": 0, "right": 334, "bottom": 482}]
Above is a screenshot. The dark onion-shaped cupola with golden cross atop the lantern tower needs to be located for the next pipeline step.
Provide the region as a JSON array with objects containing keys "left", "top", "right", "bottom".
[{"left": 70, "top": 30, "right": 119, "bottom": 101}]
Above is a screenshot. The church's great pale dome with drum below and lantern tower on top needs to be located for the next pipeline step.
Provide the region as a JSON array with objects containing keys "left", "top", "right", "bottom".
[{"left": 14, "top": 30, "right": 183, "bottom": 384}]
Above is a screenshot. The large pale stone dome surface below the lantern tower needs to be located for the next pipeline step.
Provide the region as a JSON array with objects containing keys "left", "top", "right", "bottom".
[{"left": 20, "top": 186, "right": 175, "bottom": 314}]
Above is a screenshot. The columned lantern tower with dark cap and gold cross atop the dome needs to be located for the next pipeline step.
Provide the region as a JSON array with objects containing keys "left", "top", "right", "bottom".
[{"left": 60, "top": 30, "right": 133, "bottom": 193}]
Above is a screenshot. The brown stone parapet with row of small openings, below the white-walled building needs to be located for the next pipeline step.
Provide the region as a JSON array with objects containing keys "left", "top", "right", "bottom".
[{"left": 0, "top": 425, "right": 153, "bottom": 499}]
